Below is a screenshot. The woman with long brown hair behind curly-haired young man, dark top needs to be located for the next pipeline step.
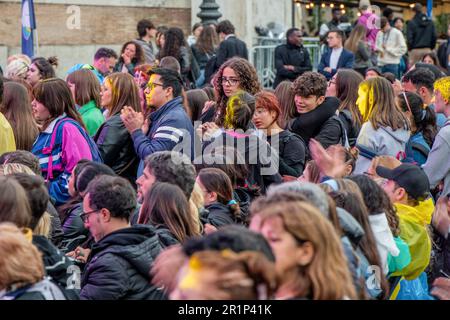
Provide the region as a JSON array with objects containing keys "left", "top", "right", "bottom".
[{"left": 327, "top": 69, "right": 364, "bottom": 147}]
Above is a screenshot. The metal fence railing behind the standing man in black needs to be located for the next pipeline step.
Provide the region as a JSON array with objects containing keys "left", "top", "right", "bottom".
[{"left": 250, "top": 38, "right": 320, "bottom": 88}]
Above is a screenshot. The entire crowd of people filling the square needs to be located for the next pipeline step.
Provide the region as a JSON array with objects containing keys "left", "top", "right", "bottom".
[{"left": 0, "top": 6, "right": 450, "bottom": 300}]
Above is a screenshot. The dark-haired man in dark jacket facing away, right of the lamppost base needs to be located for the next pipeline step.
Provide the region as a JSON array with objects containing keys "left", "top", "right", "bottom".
[{"left": 215, "top": 20, "right": 248, "bottom": 71}]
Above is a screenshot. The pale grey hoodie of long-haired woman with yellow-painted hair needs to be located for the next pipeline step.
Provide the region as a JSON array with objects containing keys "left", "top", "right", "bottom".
[{"left": 354, "top": 121, "right": 410, "bottom": 174}]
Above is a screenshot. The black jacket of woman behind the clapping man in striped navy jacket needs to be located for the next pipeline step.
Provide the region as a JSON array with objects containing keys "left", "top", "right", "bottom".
[{"left": 94, "top": 114, "right": 139, "bottom": 185}]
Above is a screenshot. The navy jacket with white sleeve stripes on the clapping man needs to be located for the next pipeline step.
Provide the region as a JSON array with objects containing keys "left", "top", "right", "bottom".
[{"left": 131, "top": 97, "right": 194, "bottom": 177}]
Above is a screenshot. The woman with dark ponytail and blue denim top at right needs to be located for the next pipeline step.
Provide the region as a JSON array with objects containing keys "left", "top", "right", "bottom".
[{"left": 396, "top": 92, "right": 438, "bottom": 165}]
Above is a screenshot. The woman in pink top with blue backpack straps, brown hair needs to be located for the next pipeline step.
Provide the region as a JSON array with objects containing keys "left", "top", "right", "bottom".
[{"left": 31, "top": 78, "right": 101, "bottom": 206}]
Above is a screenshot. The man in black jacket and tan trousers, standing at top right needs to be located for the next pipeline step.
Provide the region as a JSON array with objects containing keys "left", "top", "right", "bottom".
[{"left": 407, "top": 3, "right": 437, "bottom": 65}]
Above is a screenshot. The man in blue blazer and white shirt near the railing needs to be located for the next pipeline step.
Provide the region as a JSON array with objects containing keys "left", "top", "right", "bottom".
[{"left": 318, "top": 30, "right": 355, "bottom": 80}]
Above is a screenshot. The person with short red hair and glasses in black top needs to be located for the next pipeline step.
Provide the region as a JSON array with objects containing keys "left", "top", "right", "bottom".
[{"left": 252, "top": 91, "right": 306, "bottom": 177}]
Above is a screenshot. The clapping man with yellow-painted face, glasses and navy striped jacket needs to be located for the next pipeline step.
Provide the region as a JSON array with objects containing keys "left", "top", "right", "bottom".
[{"left": 121, "top": 69, "right": 194, "bottom": 177}]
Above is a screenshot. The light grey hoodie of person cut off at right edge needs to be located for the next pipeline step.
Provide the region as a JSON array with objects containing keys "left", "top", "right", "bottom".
[{"left": 422, "top": 118, "right": 450, "bottom": 195}]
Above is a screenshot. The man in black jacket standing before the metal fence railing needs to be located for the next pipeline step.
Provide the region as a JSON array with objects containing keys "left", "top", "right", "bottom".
[{"left": 273, "top": 28, "right": 312, "bottom": 89}]
